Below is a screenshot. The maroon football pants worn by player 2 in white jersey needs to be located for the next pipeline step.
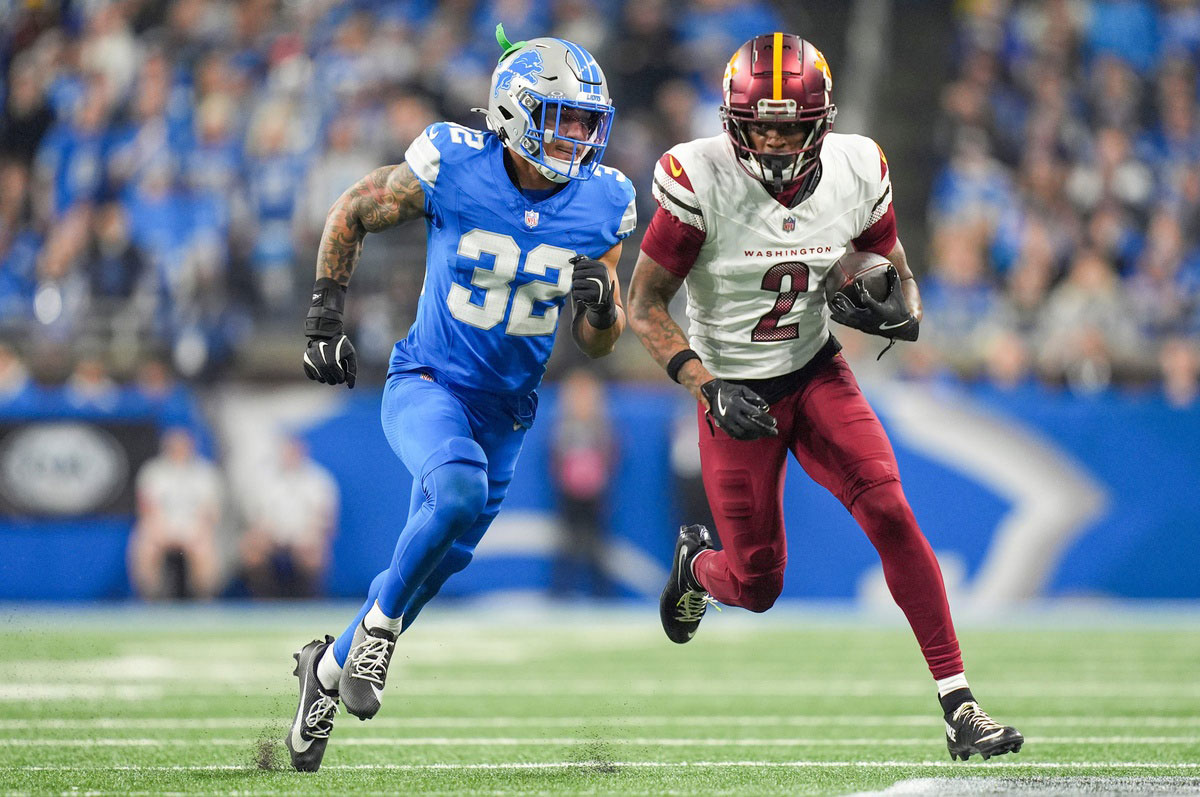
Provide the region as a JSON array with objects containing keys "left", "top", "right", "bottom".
[{"left": 694, "top": 354, "right": 962, "bottom": 678}]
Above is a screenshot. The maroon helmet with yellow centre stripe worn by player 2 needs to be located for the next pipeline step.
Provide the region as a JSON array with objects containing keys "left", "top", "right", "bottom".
[{"left": 721, "top": 34, "right": 838, "bottom": 192}]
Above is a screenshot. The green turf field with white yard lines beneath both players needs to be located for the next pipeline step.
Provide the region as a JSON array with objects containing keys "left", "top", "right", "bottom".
[{"left": 0, "top": 606, "right": 1200, "bottom": 795}]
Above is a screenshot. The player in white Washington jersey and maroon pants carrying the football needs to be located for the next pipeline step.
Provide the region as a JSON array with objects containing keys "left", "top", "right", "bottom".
[{"left": 629, "top": 32, "right": 1024, "bottom": 760}]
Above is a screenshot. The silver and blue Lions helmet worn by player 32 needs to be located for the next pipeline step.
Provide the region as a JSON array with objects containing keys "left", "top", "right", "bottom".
[{"left": 486, "top": 37, "right": 613, "bottom": 182}]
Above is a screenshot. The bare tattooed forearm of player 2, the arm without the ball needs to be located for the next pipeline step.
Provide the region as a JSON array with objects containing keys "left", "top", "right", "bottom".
[{"left": 629, "top": 252, "right": 713, "bottom": 407}]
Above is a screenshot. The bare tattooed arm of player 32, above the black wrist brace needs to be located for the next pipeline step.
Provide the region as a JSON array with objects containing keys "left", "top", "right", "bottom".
[{"left": 317, "top": 163, "right": 425, "bottom": 286}]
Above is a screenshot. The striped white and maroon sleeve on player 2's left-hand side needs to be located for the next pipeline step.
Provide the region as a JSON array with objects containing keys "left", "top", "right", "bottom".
[{"left": 642, "top": 152, "right": 708, "bottom": 277}]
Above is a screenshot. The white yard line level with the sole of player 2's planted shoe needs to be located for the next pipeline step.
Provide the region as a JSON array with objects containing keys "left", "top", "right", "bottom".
[{"left": 0, "top": 736, "right": 1200, "bottom": 749}]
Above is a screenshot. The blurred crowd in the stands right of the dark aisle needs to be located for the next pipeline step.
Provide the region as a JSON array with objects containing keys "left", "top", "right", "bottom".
[{"left": 914, "top": 0, "right": 1200, "bottom": 393}]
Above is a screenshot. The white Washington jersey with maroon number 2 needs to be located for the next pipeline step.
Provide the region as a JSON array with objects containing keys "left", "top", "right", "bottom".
[{"left": 654, "top": 133, "right": 892, "bottom": 379}]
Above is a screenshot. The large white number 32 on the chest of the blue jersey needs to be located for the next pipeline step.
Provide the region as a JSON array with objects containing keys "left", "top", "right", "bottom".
[{"left": 446, "top": 229, "right": 575, "bottom": 335}]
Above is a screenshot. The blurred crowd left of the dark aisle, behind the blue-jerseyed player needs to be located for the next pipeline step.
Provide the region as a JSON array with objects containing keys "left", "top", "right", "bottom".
[{"left": 0, "top": 0, "right": 781, "bottom": 378}]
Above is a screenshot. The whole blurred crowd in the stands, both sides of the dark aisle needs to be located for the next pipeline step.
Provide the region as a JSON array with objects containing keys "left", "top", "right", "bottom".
[{"left": 0, "top": 0, "right": 1200, "bottom": 403}]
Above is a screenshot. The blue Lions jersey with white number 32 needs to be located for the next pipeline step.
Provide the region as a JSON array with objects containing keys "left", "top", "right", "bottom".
[{"left": 390, "top": 122, "right": 636, "bottom": 396}]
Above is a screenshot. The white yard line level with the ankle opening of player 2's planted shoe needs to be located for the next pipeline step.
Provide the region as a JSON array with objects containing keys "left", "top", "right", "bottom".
[{"left": 7, "top": 713, "right": 1200, "bottom": 732}]
